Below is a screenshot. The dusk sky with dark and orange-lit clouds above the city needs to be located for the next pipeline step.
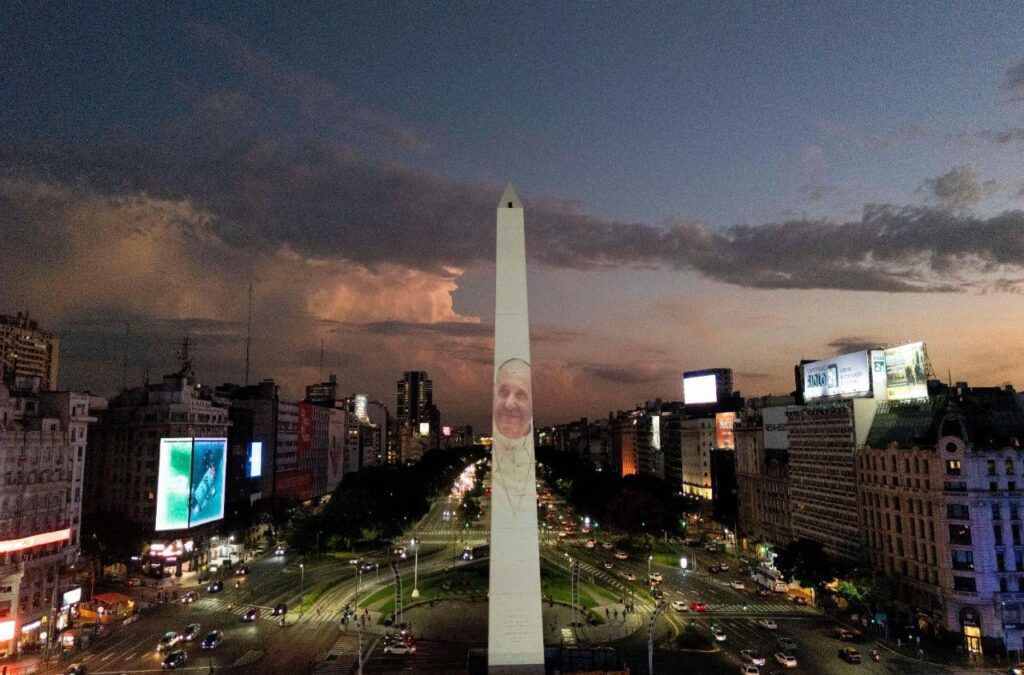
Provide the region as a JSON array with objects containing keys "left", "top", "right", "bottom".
[{"left": 0, "top": 2, "right": 1024, "bottom": 429}]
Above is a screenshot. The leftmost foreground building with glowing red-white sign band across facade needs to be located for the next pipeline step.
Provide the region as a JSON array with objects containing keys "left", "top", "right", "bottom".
[{"left": 0, "top": 383, "right": 95, "bottom": 657}]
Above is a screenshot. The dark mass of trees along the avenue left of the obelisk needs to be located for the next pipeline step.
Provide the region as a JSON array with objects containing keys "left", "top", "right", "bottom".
[{"left": 288, "top": 447, "right": 484, "bottom": 552}]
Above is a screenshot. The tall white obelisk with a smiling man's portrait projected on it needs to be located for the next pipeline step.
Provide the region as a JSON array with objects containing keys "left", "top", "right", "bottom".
[{"left": 487, "top": 184, "right": 544, "bottom": 673}]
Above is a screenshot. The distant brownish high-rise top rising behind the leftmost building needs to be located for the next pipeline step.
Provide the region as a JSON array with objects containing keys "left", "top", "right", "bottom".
[{"left": 0, "top": 312, "right": 60, "bottom": 391}]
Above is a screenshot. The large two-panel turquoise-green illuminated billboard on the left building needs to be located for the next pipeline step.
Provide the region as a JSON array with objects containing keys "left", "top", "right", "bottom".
[{"left": 155, "top": 438, "right": 227, "bottom": 531}]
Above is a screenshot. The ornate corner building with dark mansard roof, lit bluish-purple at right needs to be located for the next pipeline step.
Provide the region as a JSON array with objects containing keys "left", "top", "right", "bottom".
[{"left": 856, "top": 383, "right": 1024, "bottom": 656}]
